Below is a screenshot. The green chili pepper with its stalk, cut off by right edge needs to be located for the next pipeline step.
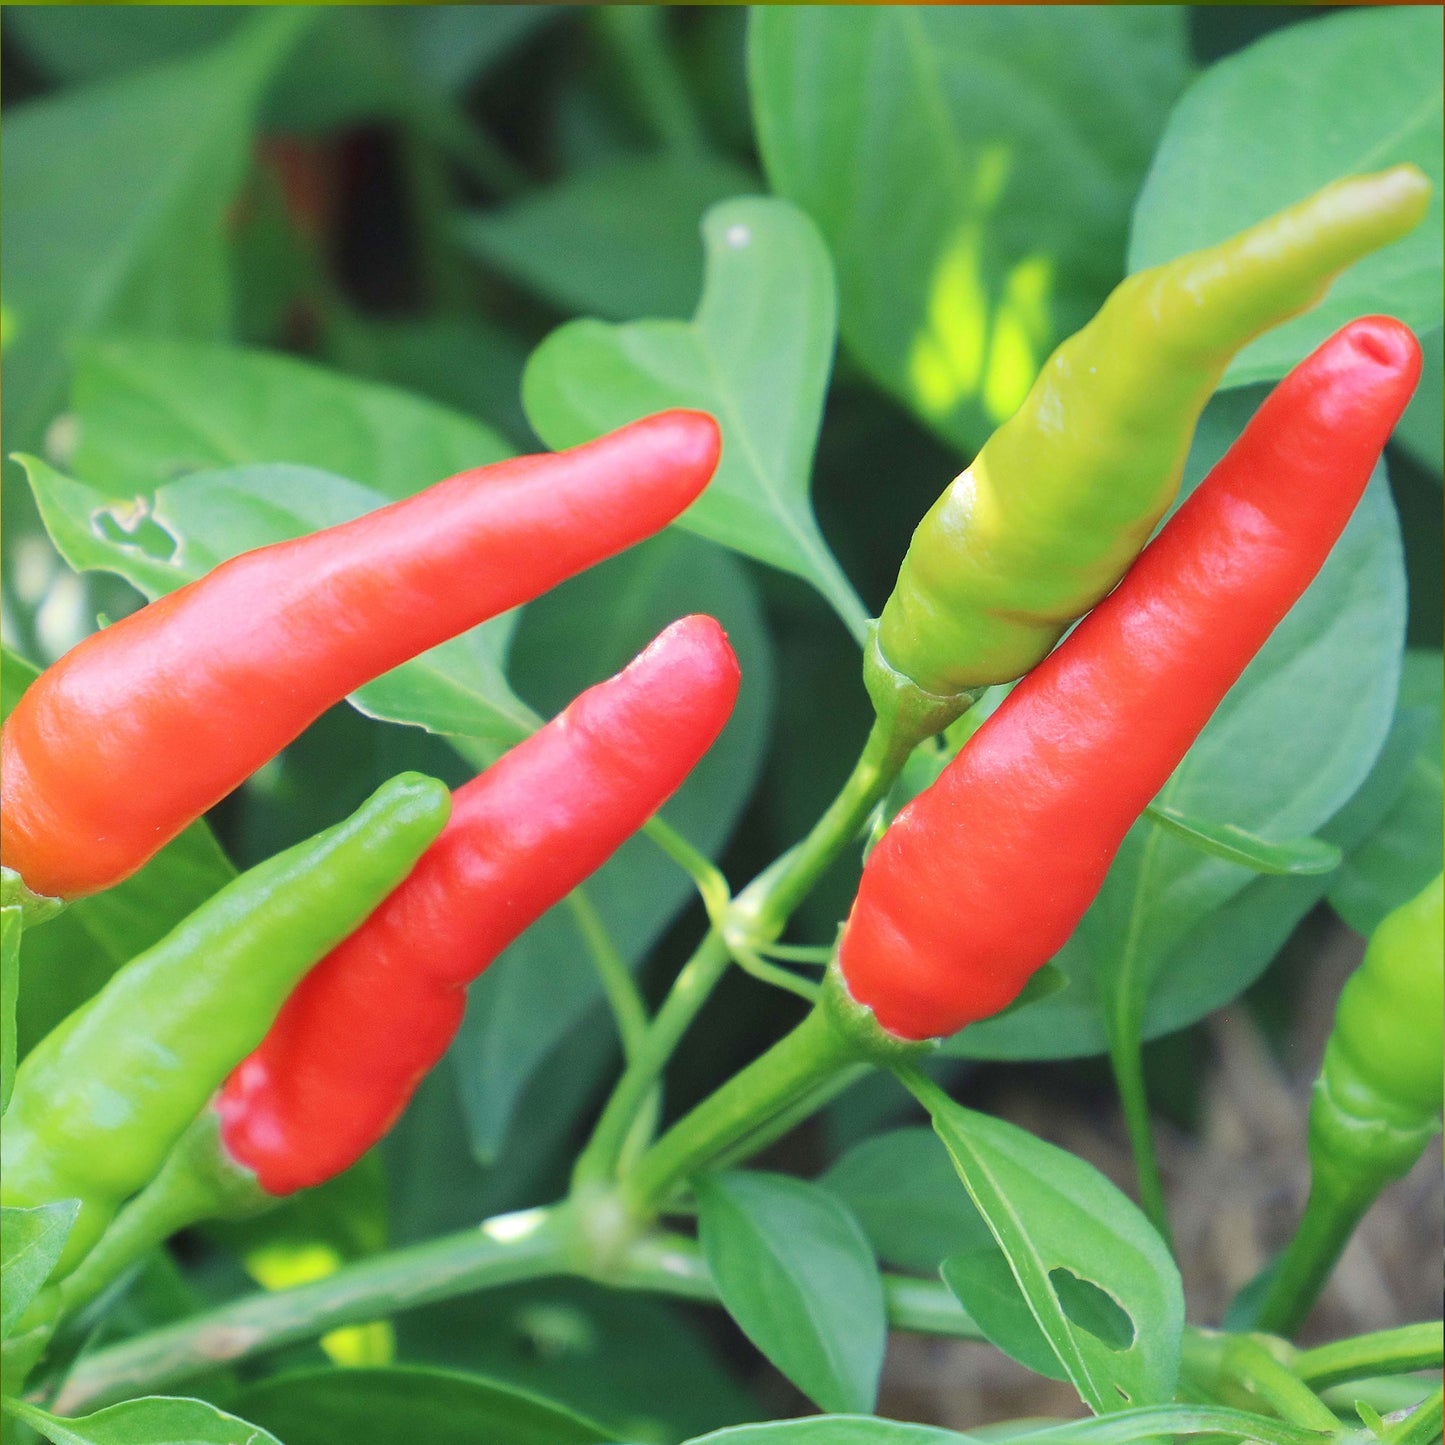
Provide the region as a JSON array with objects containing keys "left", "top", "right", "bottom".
[{"left": 1257, "top": 876, "right": 1445, "bottom": 1334}]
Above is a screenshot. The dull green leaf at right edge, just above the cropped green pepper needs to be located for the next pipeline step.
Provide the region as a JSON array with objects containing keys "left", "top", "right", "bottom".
[{"left": 1329, "top": 650, "right": 1445, "bottom": 936}]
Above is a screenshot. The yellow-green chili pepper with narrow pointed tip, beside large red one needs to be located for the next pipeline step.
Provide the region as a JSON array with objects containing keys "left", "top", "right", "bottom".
[{"left": 867, "top": 166, "right": 1431, "bottom": 705}]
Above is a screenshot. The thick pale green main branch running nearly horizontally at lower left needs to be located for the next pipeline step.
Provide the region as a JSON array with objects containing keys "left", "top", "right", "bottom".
[{"left": 55, "top": 1205, "right": 980, "bottom": 1415}]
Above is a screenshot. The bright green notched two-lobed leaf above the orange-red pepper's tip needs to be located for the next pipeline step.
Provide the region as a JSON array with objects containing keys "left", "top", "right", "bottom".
[{"left": 522, "top": 198, "right": 867, "bottom": 640}]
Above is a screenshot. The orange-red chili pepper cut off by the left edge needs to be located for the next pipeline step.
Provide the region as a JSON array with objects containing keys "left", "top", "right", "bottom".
[{"left": 0, "top": 410, "right": 720, "bottom": 899}]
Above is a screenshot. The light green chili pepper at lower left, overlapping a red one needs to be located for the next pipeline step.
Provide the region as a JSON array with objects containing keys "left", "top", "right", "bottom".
[{"left": 0, "top": 773, "right": 451, "bottom": 1272}]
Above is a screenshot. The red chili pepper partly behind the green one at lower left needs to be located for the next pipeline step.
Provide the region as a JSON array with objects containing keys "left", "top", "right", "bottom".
[{"left": 217, "top": 617, "right": 738, "bottom": 1195}]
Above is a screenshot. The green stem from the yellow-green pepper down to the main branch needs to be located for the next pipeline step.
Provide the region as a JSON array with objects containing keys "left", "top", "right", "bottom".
[{"left": 572, "top": 725, "right": 909, "bottom": 1186}]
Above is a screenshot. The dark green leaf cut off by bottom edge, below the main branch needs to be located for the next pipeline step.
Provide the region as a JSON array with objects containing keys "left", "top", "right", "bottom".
[{"left": 236, "top": 1366, "right": 614, "bottom": 1445}]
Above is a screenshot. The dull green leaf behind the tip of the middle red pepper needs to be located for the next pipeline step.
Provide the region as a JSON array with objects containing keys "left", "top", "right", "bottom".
[{"left": 452, "top": 530, "right": 773, "bottom": 1159}]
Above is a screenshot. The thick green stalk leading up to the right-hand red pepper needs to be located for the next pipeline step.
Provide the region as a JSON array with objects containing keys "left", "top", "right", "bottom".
[{"left": 621, "top": 1009, "right": 858, "bottom": 1220}]
